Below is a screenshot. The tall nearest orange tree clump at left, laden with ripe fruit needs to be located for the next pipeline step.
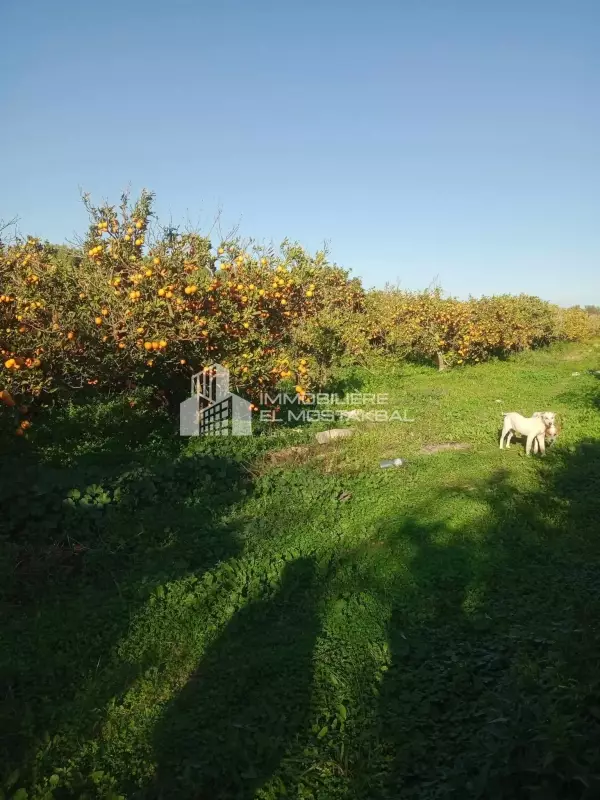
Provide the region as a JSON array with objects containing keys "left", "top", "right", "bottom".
[{"left": 0, "top": 192, "right": 363, "bottom": 422}]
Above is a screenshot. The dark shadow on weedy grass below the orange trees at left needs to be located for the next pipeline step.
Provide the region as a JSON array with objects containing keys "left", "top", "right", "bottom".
[{"left": 0, "top": 440, "right": 251, "bottom": 786}]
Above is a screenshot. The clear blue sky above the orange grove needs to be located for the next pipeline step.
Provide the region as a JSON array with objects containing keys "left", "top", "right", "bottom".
[{"left": 0, "top": 0, "right": 600, "bottom": 304}]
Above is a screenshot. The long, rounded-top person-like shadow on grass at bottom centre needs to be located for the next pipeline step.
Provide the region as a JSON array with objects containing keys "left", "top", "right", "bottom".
[{"left": 143, "top": 557, "right": 319, "bottom": 800}]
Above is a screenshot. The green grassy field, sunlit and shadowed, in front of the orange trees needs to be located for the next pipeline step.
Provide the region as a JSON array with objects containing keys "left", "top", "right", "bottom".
[{"left": 0, "top": 345, "right": 600, "bottom": 800}]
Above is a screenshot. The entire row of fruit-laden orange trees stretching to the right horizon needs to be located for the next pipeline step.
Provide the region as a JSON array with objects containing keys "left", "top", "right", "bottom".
[{"left": 0, "top": 192, "right": 597, "bottom": 433}]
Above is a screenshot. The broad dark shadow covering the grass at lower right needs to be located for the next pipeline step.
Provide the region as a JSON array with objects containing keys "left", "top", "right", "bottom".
[{"left": 351, "top": 441, "right": 600, "bottom": 800}]
